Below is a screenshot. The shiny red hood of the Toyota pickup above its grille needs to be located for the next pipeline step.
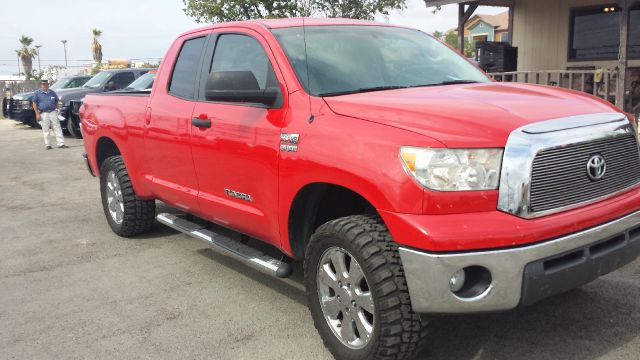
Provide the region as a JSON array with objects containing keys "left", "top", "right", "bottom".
[{"left": 324, "top": 82, "right": 619, "bottom": 147}]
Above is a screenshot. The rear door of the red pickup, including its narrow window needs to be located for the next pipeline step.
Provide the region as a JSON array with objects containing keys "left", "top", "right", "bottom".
[{"left": 145, "top": 34, "right": 207, "bottom": 214}]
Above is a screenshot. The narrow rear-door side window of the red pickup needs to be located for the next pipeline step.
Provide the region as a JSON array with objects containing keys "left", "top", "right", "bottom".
[{"left": 169, "top": 37, "right": 205, "bottom": 99}]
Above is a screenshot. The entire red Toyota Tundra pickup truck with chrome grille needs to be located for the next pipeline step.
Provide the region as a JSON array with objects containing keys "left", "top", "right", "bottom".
[{"left": 81, "top": 19, "right": 640, "bottom": 359}]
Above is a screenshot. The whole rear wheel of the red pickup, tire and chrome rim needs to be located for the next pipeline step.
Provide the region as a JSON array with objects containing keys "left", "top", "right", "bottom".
[{"left": 100, "top": 155, "right": 156, "bottom": 237}]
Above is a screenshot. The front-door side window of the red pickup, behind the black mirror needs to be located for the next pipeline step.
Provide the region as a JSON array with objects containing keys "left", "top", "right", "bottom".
[{"left": 208, "top": 34, "right": 279, "bottom": 90}]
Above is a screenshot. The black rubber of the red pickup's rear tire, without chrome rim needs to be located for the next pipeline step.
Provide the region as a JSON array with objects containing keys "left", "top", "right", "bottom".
[{"left": 100, "top": 155, "right": 156, "bottom": 237}]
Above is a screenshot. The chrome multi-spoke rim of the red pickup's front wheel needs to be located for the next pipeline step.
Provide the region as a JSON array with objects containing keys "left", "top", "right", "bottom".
[{"left": 316, "top": 247, "right": 376, "bottom": 349}]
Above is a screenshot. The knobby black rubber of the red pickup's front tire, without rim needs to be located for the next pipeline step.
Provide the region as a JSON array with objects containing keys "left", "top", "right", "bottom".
[{"left": 304, "top": 215, "right": 429, "bottom": 360}]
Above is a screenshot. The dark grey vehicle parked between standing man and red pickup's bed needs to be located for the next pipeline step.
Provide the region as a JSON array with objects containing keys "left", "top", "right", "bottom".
[{"left": 57, "top": 68, "right": 151, "bottom": 138}]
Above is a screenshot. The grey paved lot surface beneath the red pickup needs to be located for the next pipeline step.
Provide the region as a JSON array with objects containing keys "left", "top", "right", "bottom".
[{"left": 0, "top": 116, "right": 640, "bottom": 360}]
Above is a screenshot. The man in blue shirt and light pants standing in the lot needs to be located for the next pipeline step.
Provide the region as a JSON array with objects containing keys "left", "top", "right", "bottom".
[{"left": 33, "top": 80, "right": 68, "bottom": 150}]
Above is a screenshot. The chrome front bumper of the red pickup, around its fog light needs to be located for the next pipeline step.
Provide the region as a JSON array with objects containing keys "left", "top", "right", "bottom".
[{"left": 399, "top": 211, "right": 640, "bottom": 313}]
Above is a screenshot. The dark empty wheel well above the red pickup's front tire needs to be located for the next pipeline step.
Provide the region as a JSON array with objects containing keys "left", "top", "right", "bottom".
[{"left": 289, "top": 183, "right": 377, "bottom": 259}]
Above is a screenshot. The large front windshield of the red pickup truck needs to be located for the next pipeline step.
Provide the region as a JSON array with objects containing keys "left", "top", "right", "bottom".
[{"left": 272, "top": 26, "right": 489, "bottom": 96}]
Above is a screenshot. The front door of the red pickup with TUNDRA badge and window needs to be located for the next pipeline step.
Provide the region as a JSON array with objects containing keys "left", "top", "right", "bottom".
[{"left": 191, "top": 30, "right": 284, "bottom": 243}]
